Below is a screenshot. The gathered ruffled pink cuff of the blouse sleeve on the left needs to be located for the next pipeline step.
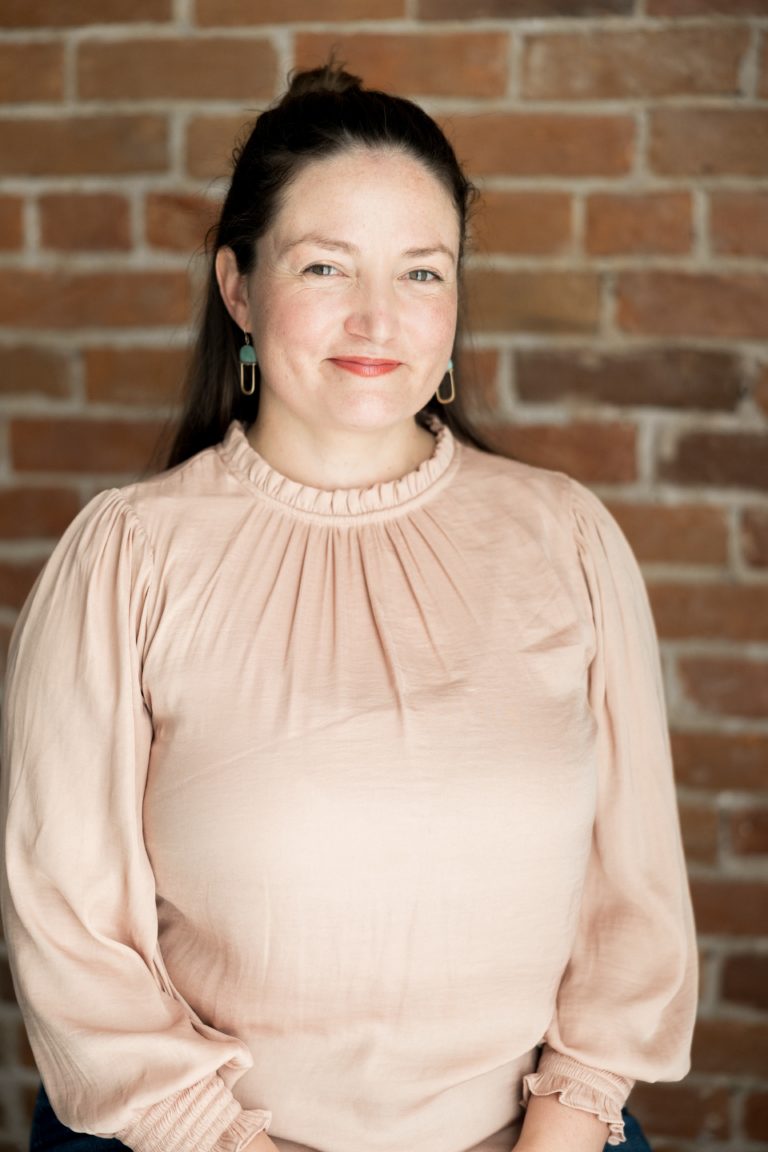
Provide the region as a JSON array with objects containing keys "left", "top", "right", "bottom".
[{"left": 115, "top": 1076, "right": 272, "bottom": 1152}]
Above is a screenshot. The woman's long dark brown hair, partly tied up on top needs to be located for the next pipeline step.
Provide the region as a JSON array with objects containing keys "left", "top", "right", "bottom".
[{"left": 166, "top": 62, "right": 486, "bottom": 467}]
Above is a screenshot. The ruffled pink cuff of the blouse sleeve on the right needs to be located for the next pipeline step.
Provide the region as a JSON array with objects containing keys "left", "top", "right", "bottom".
[{"left": 523, "top": 1047, "right": 634, "bottom": 1144}]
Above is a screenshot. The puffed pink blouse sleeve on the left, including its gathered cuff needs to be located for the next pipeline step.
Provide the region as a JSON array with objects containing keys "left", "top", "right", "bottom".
[{"left": 0, "top": 491, "right": 271, "bottom": 1152}]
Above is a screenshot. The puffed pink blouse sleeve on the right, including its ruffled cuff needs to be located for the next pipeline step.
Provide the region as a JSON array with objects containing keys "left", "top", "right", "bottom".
[{"left": 524, "top": 484, "right": 697, "bottom": 1144}]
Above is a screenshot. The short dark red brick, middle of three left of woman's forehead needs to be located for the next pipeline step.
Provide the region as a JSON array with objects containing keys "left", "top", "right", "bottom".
[{"left": 39, "top": 192, "right": 131, "bottom": 252}]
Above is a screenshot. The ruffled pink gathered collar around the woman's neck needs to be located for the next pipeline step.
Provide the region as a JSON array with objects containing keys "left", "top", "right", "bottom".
[{"left": 218, "top": 412, "right": 458, "bottom": 520}]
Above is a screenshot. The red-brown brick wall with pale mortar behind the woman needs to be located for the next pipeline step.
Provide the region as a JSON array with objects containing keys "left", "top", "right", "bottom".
[{"left": 0, "top": 0, "right": 768, "bottom": 1152}]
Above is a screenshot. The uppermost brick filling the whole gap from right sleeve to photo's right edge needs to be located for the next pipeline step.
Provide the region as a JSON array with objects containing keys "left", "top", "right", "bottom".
[{"left": 648, "top": 583, "right": 768, "bottom": 643}]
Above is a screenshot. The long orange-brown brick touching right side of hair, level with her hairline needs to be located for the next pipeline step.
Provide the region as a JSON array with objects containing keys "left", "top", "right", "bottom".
[{"left": 444, "top": 112, "right": 634, "bottom": 176}]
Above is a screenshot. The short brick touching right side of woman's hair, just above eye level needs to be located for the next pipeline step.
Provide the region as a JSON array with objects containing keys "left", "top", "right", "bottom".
[{"left": 471, "top": 189, "right": 571, "bottom": 256}]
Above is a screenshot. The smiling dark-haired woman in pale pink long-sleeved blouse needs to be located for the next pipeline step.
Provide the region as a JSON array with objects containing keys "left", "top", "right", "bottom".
[{"left": 5, "top": 60, "right": 695, "bottom": 1152}]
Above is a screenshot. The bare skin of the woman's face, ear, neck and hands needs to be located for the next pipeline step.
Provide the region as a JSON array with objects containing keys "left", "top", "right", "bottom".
[{"left": 216, "top": 149, "right": 608, "bottom": 1152}]
